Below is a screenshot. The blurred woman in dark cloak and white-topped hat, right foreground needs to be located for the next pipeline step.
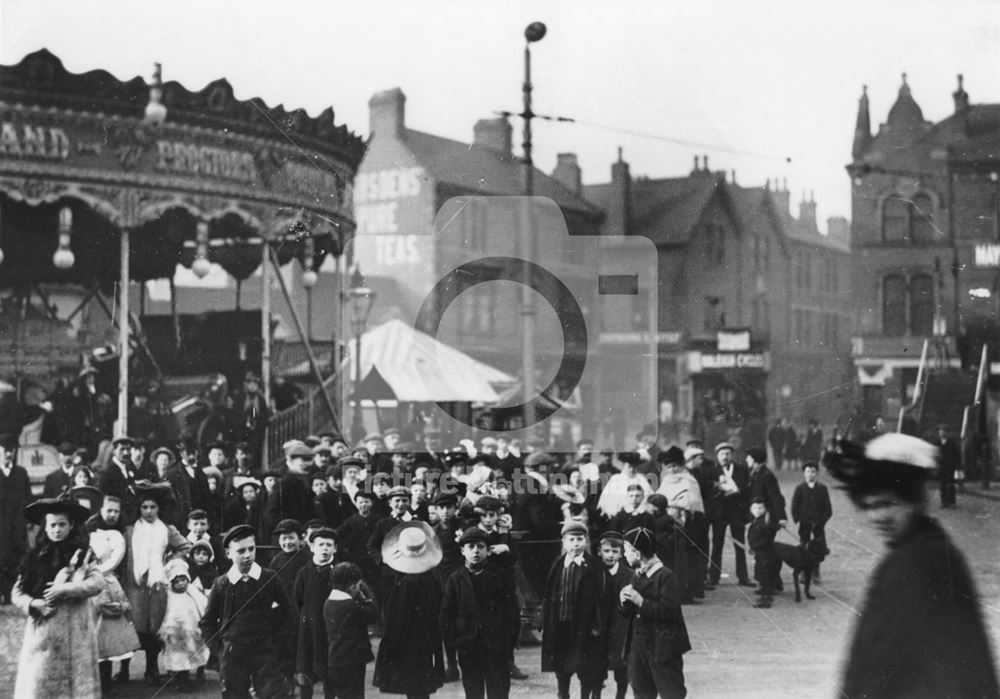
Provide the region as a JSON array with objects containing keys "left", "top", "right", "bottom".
[{"left": 827, "top": 434, "right": 1000, "bottom": 697}]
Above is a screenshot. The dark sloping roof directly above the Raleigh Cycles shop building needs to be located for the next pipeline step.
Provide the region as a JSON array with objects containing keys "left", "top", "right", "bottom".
[{"left": 583, "top": 173, "right": 724, "bottom": 245}]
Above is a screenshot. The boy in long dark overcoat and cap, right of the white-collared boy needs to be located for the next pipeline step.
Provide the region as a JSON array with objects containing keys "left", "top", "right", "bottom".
[{"left": 292, "top": 527, "right": 341, "bottom": 699}]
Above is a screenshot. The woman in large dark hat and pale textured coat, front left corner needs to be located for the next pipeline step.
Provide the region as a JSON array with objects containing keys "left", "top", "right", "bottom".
[{"left": 11, "top": 498, "right": 104, "bottom": 698}]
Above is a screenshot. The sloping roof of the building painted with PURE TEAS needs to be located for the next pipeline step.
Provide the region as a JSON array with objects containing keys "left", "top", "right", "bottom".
[{"left": 405, "top": 129, "right": 601, "bottom": 216}]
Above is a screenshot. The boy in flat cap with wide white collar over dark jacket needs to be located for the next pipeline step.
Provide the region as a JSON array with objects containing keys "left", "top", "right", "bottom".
[{"left": 201, "top": 524, "right": 295, "bottom": 699}]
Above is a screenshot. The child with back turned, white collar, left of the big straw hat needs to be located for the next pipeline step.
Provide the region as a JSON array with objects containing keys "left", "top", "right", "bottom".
[{"left": 323, "top": 563, "right": 379, "bottom": 699}]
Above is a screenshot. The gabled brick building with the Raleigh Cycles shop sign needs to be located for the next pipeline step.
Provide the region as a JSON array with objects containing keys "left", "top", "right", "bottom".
[{"left": 584, "top": 154, "right": 850, "bottom": 443}]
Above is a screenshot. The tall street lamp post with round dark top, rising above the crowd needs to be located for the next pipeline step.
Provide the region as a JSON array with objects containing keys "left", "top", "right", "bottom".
[{"left": 520, "top": 22, "right": 546, "bottom": 429}]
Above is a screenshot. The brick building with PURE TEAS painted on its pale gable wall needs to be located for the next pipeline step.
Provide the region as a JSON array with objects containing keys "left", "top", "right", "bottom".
[{"left": 353, "top": 88, "right": 602, "bottom": 440}]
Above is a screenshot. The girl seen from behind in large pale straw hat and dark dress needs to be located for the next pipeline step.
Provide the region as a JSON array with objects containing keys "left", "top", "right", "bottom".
[{"left": 373, "top": 520, "right": 445, "bottom": 698}]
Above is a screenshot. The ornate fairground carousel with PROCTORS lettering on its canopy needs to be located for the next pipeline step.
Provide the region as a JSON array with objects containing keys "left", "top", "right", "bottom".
[{"left": 0, "top": 50, "right": 364, "bottom": 476}]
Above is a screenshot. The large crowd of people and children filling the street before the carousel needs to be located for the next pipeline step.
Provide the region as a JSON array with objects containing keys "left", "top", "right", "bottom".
[{"left": 0, "top": 418, "right": 996, "bottom": 699}]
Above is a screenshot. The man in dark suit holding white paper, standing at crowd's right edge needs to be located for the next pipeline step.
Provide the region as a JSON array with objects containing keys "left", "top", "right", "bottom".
[{"left": 708, "top": 442, "right": 756, "bottom": 587}]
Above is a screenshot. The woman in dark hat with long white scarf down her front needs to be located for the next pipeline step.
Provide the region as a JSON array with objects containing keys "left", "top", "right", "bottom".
[{"left": 124, "top": 481, "right": 191, "bottom": 686}]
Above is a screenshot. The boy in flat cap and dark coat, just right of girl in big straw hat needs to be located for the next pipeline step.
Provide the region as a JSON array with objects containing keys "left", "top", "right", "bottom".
[{"left": 441, "top": 527, "right": 521, "bottom": 699}]
